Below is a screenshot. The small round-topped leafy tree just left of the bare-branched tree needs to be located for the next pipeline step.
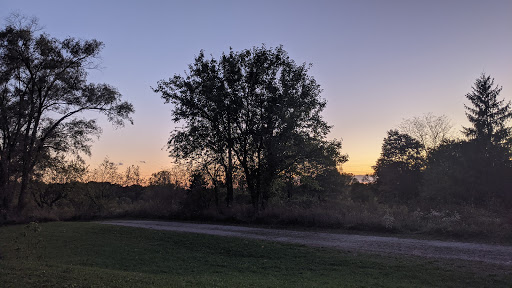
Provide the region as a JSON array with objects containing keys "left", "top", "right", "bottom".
[{"left": 373, "top": 130, "right": 424, "bottom": 202}]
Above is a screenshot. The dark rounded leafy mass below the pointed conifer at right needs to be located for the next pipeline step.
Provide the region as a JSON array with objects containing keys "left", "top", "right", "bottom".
[{"left": 421, "top": 140, "right": 512, "bottom": 208}]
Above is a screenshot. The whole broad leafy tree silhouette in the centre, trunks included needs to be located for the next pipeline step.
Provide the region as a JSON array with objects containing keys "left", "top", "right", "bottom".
[{"left": 154, "top": 46, "right": 346, "bottom": 208}]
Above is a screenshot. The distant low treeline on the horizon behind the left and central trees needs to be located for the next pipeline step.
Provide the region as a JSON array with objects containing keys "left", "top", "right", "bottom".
[{"left": 18, "top": 155, "right": 357, "bottom": 220}]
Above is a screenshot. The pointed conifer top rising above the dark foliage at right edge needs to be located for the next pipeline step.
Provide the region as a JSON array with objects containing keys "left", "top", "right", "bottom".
[{"left": 463, "top": 74, "right": 512, "bottom": 150}]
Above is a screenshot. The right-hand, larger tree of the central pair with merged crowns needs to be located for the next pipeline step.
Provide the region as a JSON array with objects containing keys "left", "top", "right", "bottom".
[{"left": 231, "top": 47, "right": 347, "bottom": 207}]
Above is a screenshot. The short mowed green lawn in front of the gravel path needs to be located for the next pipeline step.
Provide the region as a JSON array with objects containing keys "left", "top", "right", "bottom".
[{"left": 0, "top": 222, "right": 512, "bottom": 287}]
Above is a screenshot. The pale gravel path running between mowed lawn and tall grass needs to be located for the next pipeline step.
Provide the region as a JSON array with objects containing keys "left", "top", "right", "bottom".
[{"left": 101, "top": 220, "right": 512, "bottom": 266}]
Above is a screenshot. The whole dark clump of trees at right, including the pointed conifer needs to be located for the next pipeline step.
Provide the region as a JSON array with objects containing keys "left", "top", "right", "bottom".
[{"left": 374, "top": 74, "right": 512, "bottom": 208}]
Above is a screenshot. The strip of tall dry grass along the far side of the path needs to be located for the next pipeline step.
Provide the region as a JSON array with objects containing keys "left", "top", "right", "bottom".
[{"left": 0, "top": 189, "right": 512, "bottom": 244}]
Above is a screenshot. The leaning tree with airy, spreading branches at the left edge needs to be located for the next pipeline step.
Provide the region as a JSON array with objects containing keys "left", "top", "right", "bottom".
[{"left": 0, "top": 18, "right": 134, "bottom": 210}]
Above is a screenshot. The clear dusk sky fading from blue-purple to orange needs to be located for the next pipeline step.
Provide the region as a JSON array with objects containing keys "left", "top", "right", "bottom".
[{"left": 0, "top": 0, "right": 512, "bottom": 176}]
